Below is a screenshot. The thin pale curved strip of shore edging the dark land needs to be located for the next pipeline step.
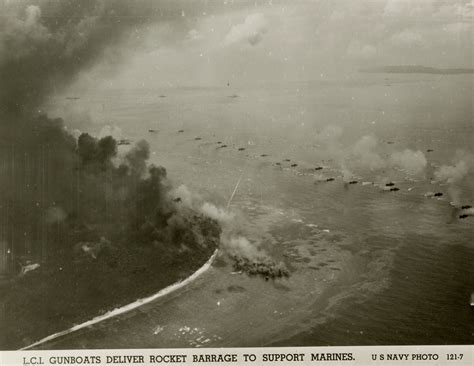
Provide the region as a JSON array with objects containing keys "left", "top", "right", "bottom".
[{"left": 20, "top": 249, "right": 218, "bottom": 351}]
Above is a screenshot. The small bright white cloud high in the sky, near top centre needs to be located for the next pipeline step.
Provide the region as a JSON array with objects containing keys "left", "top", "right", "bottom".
[{"left": 224, "top": 13, "right": 268, "bottom": 46}]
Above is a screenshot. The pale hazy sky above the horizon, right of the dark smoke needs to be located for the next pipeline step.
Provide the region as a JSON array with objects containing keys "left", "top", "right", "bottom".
[{"left": 65, "top": 0, "right": 474, "bottom": 87}]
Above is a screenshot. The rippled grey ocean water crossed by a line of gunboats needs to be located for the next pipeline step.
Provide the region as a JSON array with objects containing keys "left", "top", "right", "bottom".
[{"left": 43, "top": 75, "right": 474, "bottom": 348}]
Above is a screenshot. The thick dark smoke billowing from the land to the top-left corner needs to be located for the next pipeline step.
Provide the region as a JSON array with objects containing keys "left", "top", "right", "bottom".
[{"left": 0, "top": 0, "right": 220, "bottom": 272}]
